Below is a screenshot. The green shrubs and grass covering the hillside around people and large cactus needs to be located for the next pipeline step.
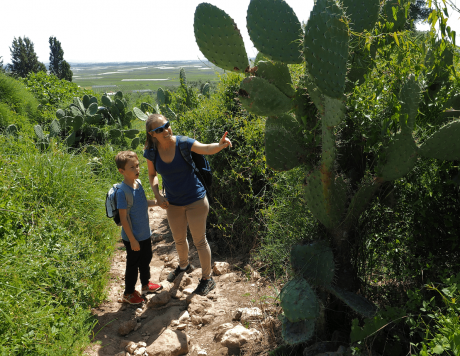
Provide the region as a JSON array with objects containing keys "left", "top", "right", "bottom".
[{"left": 0, "top": 15, "right": 460, "bottom": 355}]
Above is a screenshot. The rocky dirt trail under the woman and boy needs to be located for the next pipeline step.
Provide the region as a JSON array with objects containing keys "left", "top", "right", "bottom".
[{"left": 84, "top": 207, "right": 279, "bottom": 356}]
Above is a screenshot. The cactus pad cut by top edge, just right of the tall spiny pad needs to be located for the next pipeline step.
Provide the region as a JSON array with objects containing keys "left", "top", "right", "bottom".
[{"left": 342, "top": 0, "right": 380, "bottom": 32}]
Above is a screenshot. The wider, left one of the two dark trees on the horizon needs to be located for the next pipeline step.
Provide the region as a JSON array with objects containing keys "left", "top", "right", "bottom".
[{"left": 8, "top": 37, "right": 46, "bottom": 78}]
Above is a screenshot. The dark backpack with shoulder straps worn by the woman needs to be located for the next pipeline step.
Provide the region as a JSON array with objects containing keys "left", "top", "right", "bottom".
[{"left": 151, "top": 135, "right": 212, "bottom": 203}]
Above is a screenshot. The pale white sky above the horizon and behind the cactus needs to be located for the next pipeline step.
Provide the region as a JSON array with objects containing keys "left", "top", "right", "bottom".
[{"left": 0, "top": 0, "right": 460, "bottom": 64}]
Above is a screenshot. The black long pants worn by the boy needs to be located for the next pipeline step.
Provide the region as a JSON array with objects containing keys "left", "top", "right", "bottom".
[{"left": 123, "top": 237, "right": 153, "bottom": 295}]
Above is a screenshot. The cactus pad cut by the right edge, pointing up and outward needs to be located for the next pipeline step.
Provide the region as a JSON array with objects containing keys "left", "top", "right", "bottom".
[{"left": 419, "top": 120, "right": 460, "bottom": 160}]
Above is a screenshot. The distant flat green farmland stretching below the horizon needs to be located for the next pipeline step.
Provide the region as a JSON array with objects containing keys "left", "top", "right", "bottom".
[{"left": 71, "top": 61, "right": 223, "bottom": 92}]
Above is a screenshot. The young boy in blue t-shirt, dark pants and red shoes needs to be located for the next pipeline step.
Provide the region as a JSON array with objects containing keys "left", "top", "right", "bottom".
[{"left": 115, "top": 151, "right": 162, "bottom": 304}]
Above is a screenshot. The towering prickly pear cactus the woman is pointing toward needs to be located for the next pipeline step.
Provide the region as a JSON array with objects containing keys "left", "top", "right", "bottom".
[{"left": 194, "top": 0, "right": 460, "bottom": 344}]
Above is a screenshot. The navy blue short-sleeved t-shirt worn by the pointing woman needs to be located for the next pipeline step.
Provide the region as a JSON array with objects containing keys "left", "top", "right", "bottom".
[{"left": 144, "top": 136, "right": 206, "bottom": 206}]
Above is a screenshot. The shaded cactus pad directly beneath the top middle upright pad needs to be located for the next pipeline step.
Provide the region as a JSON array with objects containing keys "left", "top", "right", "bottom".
[{"left": 255, "top": 61, "right": 295, "bottom": 98}]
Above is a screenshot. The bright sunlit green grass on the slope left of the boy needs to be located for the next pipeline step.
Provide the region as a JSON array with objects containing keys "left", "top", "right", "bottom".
[{"left": 0, "top": 136, "right": 118, "bottom": 355}]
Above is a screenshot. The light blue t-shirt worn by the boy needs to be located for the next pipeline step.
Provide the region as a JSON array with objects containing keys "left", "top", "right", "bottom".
[{"left": 117, "top": 184, "right": 152, "bottom": 241}]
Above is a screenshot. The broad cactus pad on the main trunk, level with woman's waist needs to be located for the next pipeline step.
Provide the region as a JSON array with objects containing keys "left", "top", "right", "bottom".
[{"left": 305, "top": 170, "right": 347, "bottom": 229}]
